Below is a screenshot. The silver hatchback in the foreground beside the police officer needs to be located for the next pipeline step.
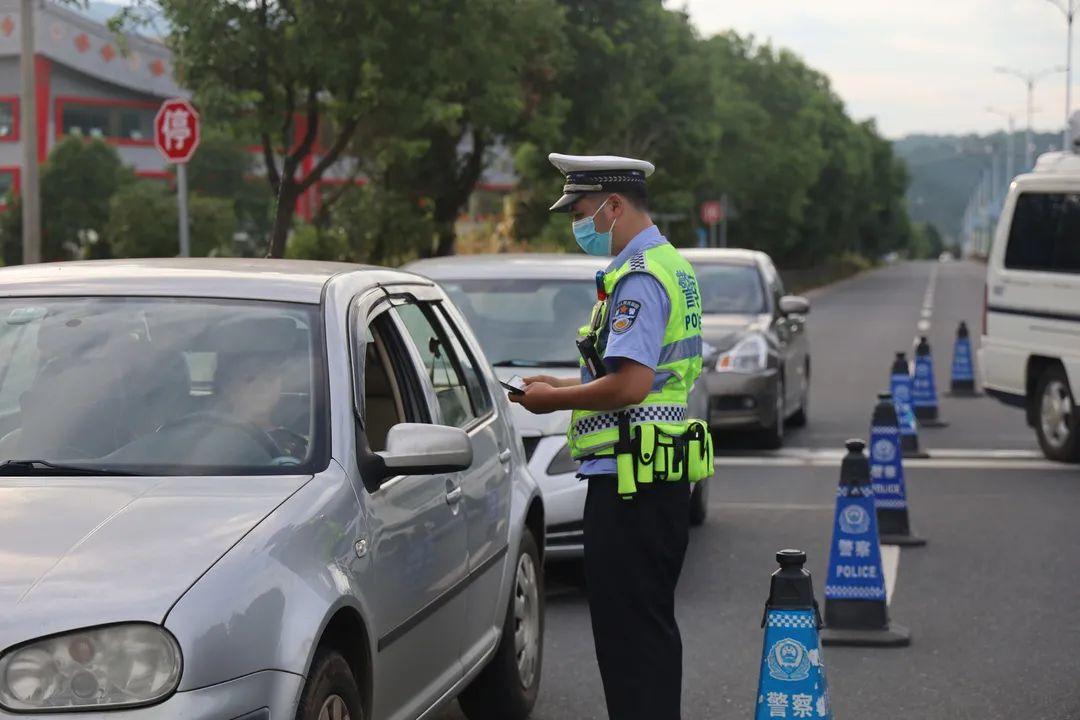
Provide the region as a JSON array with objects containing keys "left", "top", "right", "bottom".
[{"left": 0, "top": 260, "right": 544, "bottom": 720}]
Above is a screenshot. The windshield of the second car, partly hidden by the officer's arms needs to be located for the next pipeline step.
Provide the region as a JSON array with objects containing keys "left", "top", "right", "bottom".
[{"left": 441, "top": 277, "right": 596, "bottom": 367}]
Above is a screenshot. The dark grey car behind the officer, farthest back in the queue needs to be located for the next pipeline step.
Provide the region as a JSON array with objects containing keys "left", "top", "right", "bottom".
[{"left": 684, "top": 248, "right": 810, "bottom": 448}]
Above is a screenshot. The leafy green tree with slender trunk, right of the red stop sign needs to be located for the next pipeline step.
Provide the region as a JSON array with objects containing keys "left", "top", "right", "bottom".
[{"left": 113, "top": 0, "right": 454, "bottom": 257}]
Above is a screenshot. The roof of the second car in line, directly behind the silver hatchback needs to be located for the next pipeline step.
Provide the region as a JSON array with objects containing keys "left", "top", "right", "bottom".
[{"left": 403, "top": 253, "right": 610, "bottom": 281}]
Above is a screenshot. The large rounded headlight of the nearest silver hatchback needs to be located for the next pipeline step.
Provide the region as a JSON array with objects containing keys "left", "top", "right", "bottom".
[{"left": 0, "top": 623, "right": 181, "bottom": 710}]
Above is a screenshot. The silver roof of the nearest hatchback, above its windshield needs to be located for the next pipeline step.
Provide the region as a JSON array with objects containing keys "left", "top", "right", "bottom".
[{"left": 0, "top": 258, "right": 408, "bottom": 303}]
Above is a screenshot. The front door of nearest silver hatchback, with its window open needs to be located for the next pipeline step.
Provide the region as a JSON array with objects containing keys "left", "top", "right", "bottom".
[{"left": 350, "top": 302, "right": 469, "bottom": 720}]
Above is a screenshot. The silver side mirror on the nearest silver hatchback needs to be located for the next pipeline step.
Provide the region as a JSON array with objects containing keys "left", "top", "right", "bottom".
[{"left": 375, "top": 422, "right": 472, "bottom": 478}]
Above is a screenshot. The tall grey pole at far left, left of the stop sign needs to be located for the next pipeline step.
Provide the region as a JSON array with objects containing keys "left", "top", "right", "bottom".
[{"left": 18, "top": 0, "right": 41, "bottom": 264}]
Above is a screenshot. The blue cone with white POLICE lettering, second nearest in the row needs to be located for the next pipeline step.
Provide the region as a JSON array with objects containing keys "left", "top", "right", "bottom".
[{"left": 821, "top": 440, "right": 912, "bottom": 648}]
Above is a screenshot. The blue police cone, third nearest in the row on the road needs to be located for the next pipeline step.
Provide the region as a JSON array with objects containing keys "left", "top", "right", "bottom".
[{"left": 870, "top": 393, "right": 927, "bottom": 546}]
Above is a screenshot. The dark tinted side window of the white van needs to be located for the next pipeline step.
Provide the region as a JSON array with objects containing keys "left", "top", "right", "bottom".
[{"left": 1005, "top": 192, "right": 1080, "bottom": 273}]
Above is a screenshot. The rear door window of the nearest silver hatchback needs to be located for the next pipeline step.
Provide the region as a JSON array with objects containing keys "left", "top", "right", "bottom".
[{"left": 395, "top": 302, "right": 476, "bottom": 427}]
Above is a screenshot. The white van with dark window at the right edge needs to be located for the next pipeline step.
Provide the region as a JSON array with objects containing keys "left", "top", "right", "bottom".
[{"left": 978, "top": 152, "right": 1080, "bottom": 462}]
